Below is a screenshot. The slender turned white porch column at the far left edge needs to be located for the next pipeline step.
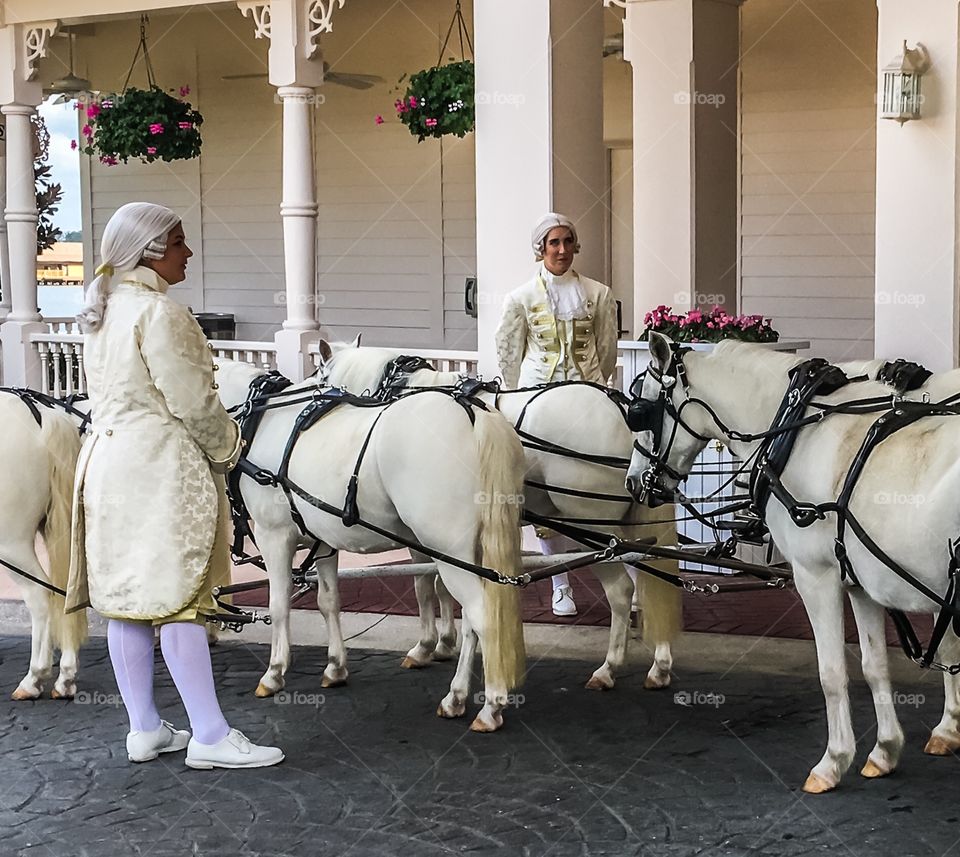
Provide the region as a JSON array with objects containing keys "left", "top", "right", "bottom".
[{"left": 0, "top": 104, "right": 44, "bottom": 386}]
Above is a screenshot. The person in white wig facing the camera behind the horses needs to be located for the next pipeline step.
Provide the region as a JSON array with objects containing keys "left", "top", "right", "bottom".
[{"left": 496, "top": 212, "right": 617, "bottom": 616}]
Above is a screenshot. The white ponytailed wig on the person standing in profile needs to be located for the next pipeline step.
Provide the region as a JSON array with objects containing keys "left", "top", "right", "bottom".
[{"left": 77, "top": 202, "right": 180, "bottom": 333}]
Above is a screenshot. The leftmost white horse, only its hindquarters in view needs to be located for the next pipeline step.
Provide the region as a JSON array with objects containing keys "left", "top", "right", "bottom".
[{"left": 0, "top": 392, "right": 87, "bottom": 700}]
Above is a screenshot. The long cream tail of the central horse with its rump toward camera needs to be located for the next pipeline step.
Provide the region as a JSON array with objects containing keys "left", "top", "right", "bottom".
[{"left": 474, "top": 408, "right": 526, "bottom": 690}]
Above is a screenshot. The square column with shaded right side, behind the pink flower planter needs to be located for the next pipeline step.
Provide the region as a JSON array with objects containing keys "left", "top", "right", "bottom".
[{"left": 618, "top": 0, "right": 739, "bottom": 330}]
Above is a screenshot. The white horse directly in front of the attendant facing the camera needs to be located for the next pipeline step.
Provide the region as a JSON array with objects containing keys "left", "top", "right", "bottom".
[{"left": 321, "top": 340, "right": 681, "bottom": 690}]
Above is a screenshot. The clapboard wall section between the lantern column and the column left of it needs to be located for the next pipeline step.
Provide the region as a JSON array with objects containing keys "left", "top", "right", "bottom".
[{"left": 740, "top": 0, "right": 877, "bottom": 359}]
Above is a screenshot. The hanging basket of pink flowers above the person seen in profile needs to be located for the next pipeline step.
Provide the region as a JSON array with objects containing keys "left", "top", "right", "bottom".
[{"left": 78, "top": 86, "right": 203, "bottom": 166}]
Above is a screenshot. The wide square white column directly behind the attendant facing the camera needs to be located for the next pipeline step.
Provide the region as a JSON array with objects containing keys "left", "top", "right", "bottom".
[{"left": 474, "top": 0, "right": 605, "bottom": 377}]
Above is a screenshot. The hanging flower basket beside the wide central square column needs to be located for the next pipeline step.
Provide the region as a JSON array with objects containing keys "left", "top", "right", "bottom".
[{"left": 392, "top": 60, "right": 474, "bottom": 143}]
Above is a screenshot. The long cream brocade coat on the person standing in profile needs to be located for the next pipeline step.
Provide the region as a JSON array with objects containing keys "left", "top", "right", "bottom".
[{"left": 67, "top": 267, "right": 239, "bottom": 619}]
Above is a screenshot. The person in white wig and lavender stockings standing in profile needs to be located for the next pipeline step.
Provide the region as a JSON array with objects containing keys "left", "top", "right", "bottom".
[{"left": 66, "top": 202, "right": 283, "bottom": 769}]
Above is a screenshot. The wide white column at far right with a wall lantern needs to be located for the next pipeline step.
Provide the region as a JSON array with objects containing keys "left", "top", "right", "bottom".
[{"left": 875, "top": 0, "right": 960, "bottom": 371}]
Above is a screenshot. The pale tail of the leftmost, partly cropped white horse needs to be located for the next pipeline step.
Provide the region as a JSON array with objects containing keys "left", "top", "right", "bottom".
[{"left": 40, "top": 412, "right": 87, "bottom": 650}]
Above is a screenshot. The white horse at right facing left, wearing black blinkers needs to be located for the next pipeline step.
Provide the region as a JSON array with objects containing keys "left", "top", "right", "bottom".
[{"left": 627, "top": 334, "right": 960, "bottom": 793}]
